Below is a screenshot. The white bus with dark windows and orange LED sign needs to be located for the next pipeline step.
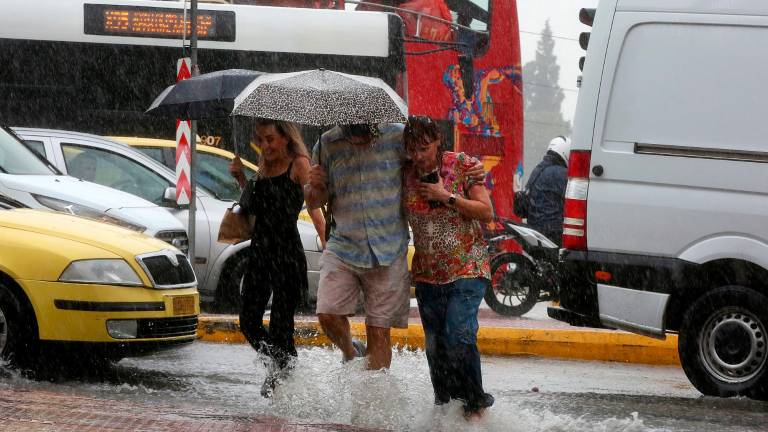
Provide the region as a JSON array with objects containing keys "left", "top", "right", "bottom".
[{"left": 0, "top": 0, "right": 407, "bottom": 153}]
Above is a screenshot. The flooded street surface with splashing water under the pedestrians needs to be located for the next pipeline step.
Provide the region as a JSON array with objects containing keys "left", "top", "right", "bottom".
[{"left": 6, "top": 342, "right": 768, "bottom": 432}]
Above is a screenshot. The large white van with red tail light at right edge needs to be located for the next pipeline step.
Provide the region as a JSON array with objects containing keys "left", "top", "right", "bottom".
[{"left": 549, "top": 0, "right": 768, "bottom": 398}]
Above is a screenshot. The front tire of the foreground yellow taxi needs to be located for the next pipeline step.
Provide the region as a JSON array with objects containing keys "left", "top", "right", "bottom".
[{"left": 0, "top": 281, "right": 38, "bottom": 367}]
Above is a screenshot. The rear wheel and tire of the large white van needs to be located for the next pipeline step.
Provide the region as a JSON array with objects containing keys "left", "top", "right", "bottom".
[{"left": 678, "top": 285, "right": 768, "bottom": 399}]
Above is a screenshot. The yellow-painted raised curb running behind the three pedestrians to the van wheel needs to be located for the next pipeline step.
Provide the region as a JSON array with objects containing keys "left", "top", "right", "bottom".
[{"left": 198, "top": 299, "right": 680, "bottom": 366}]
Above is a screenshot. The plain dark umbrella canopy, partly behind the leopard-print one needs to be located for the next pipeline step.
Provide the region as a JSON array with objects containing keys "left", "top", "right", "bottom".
[{"left": 146, "top": 69, "right": 264, "bottom": 120}]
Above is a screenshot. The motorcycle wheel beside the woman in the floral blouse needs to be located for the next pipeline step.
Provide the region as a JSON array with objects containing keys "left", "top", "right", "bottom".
[{"left": 485, "top": 253, "right": 540, "bottom": 316}]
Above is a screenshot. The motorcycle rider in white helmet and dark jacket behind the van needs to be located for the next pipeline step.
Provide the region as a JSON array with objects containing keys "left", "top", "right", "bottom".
[{"left": 526, "top": 136, "right": 571, "bottom": 246}]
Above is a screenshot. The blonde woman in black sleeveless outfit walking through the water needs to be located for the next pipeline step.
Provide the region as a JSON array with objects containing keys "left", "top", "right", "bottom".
[{"left": 231, "top": 120, "right": 324, "bottom": 397}]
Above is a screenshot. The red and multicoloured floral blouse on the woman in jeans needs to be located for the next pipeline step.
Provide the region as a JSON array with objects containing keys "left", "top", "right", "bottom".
[{"left": 403, "top": 152, "right": 490, "bottom": 284}]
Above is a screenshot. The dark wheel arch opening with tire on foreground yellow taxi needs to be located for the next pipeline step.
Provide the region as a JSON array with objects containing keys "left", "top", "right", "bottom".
[{"left": 0, "top": 273, "right": 40, "bottom": 367}]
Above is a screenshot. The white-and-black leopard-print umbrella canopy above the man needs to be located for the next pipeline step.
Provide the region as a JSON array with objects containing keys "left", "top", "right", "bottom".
[{"left": 232, "top": 69, "right": 408, "bottom": 126}]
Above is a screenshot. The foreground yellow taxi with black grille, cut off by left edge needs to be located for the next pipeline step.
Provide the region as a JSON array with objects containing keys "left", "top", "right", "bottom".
[{"left": 0, "top": 196, "right": 200, "bottom": 364}]
